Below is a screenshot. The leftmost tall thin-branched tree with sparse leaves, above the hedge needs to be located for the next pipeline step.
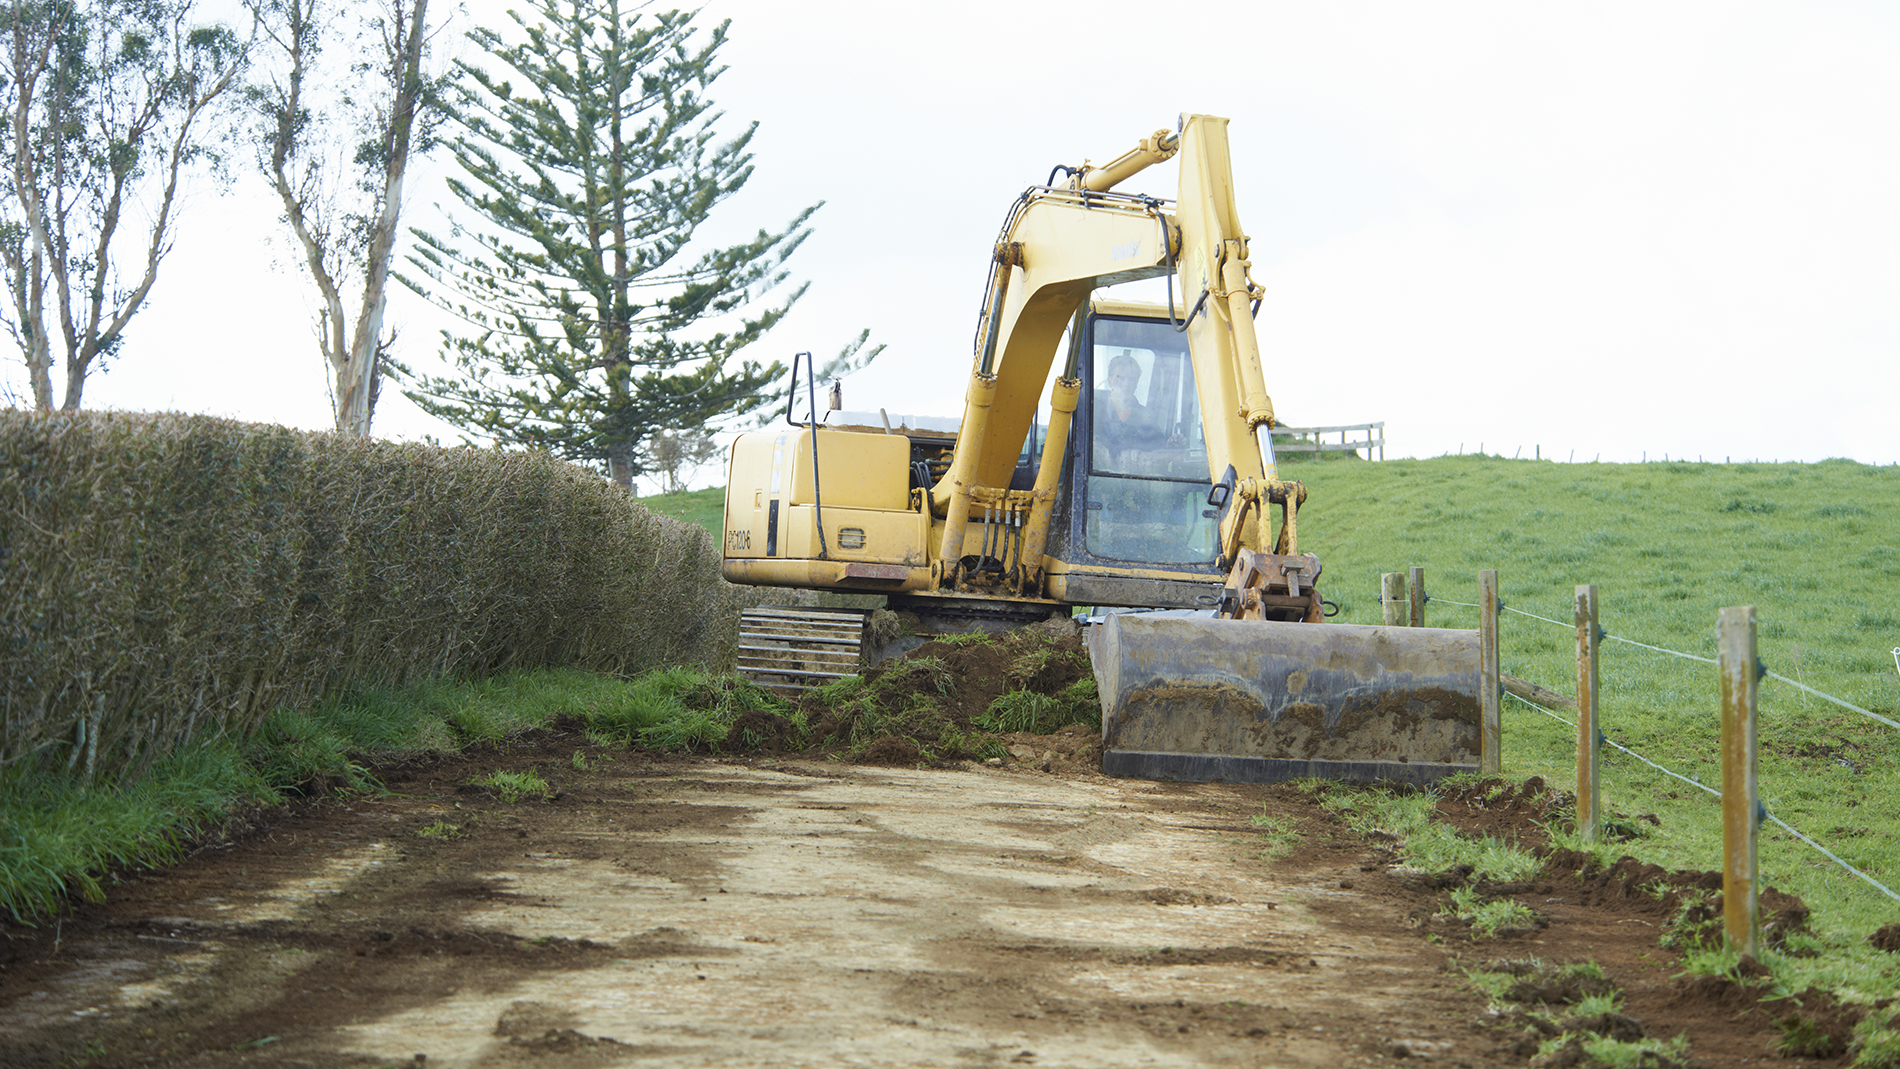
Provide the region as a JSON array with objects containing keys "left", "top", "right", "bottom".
[{"left": 0, "top": 0, "right": 245, "bottom": 412}]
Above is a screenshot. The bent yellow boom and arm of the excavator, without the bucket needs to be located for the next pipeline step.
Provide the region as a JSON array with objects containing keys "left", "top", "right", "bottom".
[{"left": 931, "top": 116, "right": 1319, "bottom": 619}]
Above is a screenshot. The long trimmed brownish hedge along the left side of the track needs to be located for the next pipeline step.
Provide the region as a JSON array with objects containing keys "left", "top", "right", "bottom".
[{"left": 0, "top": 410, "right": 737, "bottom": 782}]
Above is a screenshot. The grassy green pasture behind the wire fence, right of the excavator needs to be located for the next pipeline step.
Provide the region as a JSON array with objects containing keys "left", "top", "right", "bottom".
[{"left": 1292, "top": 456, "right": 1900, "bottom": 995}]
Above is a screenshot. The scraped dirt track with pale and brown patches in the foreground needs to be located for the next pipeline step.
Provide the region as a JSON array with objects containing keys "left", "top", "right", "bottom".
[{"left": 0, "top": 739, "right": 1524, "bottom": 1067}]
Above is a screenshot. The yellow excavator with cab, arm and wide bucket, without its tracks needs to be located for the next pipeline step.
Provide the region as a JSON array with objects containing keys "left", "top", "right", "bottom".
[{"left": 722, "top": 114, "right": 1480, "bottom": 782}]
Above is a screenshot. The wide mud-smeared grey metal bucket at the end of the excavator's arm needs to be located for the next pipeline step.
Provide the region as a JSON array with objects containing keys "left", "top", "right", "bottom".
[{"left": 1089, "top": 613, "right": 1480, "bottom": 784}]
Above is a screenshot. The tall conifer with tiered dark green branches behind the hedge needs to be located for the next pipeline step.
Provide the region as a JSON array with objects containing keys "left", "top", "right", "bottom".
[{"left": 405, "top": 0, "right": 868, "bottom": 486}]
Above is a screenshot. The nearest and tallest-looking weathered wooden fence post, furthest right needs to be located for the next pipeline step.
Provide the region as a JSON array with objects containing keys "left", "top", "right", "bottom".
[{"left": 1716, "top": 606, "right": 1761, "bottom": 955}]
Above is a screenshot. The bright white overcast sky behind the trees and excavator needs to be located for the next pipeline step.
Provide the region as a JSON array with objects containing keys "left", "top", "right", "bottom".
[{"left": 22, "top": 0, "right": 1900, "bottom": 484}]
